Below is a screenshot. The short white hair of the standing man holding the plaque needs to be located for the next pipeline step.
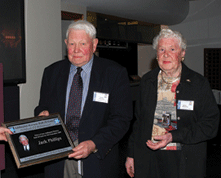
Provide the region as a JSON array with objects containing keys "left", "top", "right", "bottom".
[{"left": 66, "top": 20, "right": 96, "bottom": 39}]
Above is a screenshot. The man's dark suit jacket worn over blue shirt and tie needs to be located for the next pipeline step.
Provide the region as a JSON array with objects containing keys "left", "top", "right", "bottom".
[{"left": 35, "top": 56, "right": 132, "bottom": 178}]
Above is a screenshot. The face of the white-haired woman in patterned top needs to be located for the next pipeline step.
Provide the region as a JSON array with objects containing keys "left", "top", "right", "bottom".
[{"left": 157, "top": 38, "right": 185, "bottom": 77}]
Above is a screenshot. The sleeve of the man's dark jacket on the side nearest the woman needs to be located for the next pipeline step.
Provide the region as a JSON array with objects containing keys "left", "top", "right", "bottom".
[{"left": 92, "top": 68, "right": 133, "bottom": 159}]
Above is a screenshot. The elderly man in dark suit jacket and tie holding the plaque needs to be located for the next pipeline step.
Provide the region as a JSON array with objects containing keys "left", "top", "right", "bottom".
[{"left": 35, "top": 20, "right": 132, "bottom": 178}]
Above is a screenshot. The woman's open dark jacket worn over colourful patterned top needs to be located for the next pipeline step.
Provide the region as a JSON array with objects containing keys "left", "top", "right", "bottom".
[{"left": 128, "top": 64, "right": 219, "bottom": 178}]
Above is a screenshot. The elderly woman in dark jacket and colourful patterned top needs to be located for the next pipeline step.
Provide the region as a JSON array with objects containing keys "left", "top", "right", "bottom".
[{"left": 125, "top": 29, "right": 219, "bottom": 178}]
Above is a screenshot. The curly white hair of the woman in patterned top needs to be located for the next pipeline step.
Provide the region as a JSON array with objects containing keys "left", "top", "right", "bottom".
[{"left": 153, "top": 29, "right": 187, "bottom": 50}]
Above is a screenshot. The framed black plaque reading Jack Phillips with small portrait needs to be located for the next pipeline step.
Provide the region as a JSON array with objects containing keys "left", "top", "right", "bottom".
[{"left": 2, "top": 114, "right": 74, "bottom": 168}]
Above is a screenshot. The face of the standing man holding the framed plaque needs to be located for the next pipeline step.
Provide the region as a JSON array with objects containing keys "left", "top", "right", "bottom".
[{"left": 65, "top": 29, "right": 98, "bottom": 67}]
